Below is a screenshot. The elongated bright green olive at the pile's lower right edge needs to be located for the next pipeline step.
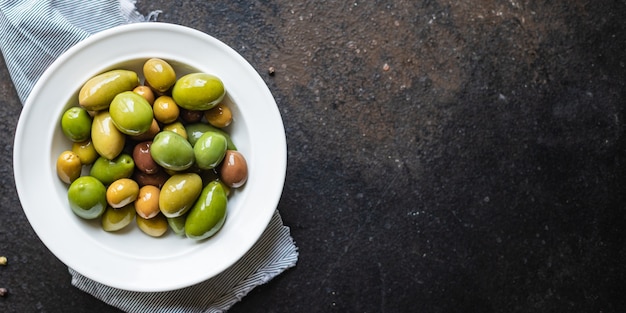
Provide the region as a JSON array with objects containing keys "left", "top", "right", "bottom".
[{"left": 185, "top": 181, "right": 228, "bottom": 240}]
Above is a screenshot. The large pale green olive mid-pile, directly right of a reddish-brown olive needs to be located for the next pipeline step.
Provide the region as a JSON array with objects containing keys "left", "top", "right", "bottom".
[{"left": 150, "top": 130, "right": 194, "bottom": 171}]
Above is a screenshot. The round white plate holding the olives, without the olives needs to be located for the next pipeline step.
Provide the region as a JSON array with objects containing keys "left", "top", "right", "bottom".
[{"left": 13, "top": 23, "right": 287, "bottom": 292}]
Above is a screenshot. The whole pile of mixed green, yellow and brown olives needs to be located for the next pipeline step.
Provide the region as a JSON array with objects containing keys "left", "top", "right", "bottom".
[{"left": 56, "top": 58, "right": 248, "bottom": 240}]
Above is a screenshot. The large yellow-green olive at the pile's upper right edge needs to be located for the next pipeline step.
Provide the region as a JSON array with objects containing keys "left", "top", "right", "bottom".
[{"left": 172, "top": 73, "right": 226, "bottom": 111}]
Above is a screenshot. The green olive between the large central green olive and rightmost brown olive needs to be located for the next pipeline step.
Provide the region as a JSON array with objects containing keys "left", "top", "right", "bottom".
[{"left": 193, "top": 131, "right": 228, "bottom": 170}]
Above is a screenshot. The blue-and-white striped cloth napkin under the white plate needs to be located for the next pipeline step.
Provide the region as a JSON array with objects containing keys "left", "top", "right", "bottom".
[{"left": 0, "top": 0, "right": 298, "bottom": 313}]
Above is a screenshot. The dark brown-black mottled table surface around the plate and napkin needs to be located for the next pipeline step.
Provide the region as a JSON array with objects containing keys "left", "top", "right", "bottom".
[{"left": 0, "top": 0, "right": 626, "bottom": 313}]
